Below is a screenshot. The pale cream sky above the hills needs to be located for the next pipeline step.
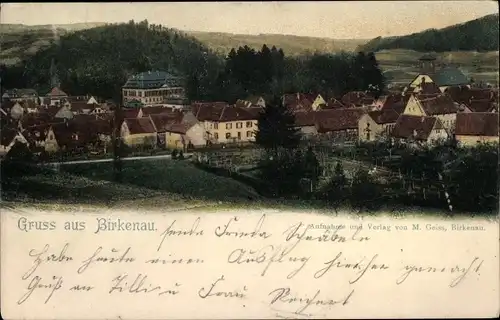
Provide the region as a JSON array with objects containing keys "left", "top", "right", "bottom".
[{"left": 0, "top": 0, "right": 498, "bottom": 39}]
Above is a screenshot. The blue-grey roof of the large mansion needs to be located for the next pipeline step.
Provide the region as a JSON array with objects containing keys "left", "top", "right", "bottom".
[{"left": 123, "top": 71, "right": 183, "bottom": 89}]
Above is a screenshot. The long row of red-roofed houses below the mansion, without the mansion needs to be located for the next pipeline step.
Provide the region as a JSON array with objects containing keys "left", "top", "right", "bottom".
[{"left": 0, "top": 85, "right": 498, "bottom": 158}]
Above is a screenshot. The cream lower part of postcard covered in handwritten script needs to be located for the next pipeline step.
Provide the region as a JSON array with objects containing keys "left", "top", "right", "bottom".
[{"left": 1, "top": 212, "right": 498, "bottom": 319}]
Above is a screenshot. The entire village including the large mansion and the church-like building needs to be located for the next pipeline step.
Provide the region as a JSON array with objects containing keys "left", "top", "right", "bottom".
[{"left": 0, "top": 55, "right": 498, "bottom": 161}]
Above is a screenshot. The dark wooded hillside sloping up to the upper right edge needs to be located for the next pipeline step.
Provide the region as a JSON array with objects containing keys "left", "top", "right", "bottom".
[{"left": 358, "top": 14, "right": 499, "bottom": 52}]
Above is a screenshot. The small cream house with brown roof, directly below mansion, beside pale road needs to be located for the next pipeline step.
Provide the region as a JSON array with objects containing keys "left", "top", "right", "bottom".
[{"left": 120, "top": 117, "right": 157, "bottom": 148}]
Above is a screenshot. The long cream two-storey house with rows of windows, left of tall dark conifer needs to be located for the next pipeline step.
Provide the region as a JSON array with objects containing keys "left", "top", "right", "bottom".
[{"left": 192, "top": 102, "right": 262, "bottom": 144}]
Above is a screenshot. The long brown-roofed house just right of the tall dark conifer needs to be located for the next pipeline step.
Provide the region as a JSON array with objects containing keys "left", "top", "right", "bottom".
[{"left": 315, "top": 108, "right": 366, "bottom": 142}]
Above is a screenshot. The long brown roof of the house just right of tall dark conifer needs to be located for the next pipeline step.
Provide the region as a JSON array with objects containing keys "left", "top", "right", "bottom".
[{"left": 315, "top": 108, "right": 366, "bottom": 133}]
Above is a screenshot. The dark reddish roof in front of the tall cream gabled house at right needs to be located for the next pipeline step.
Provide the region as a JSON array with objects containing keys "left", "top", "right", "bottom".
[{"left": 392, "top": 114, "right": 442, "bottom": 140}]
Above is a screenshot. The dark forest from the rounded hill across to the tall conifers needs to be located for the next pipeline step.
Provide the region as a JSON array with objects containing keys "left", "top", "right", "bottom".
[{"left": 0, "top": 20, "right": 384, "bottom": 103}]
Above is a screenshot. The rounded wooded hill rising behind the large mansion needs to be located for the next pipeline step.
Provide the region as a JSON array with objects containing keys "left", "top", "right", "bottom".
[{"left": 5, "top": 22, "right": 223, "bottom": 98}]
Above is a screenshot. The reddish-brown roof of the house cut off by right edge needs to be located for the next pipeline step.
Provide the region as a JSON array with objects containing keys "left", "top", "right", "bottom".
[{"left": 455, "top": 112, "right": 498, "bottom": 137}]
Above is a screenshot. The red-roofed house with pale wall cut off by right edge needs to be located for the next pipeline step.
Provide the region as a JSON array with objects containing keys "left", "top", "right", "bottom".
[{"left": 455, "top": 112, "right": 499, "bottom": 146}]
